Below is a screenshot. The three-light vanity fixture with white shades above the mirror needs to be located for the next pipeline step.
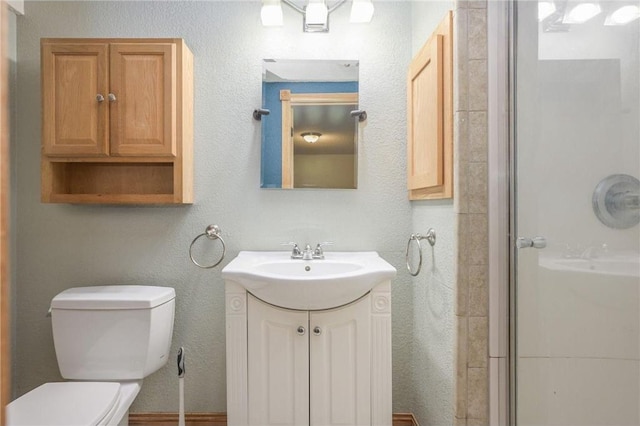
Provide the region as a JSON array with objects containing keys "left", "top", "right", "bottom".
[{"left": 260, "top": 0, "right": 374, "bottom": 33}]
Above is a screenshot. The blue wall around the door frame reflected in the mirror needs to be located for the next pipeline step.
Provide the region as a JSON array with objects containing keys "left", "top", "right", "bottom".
[{"left": 260, "top": 81, "right": 358, "bottom": 188}]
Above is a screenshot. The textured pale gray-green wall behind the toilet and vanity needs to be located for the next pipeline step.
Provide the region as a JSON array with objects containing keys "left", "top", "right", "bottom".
[{"left": 13, "top": 1, "right": 428, "bottom": 412}]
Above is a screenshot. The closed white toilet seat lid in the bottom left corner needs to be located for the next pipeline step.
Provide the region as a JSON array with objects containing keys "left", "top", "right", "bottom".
[{"left": 6, "top": 382, "right": 120, "bottom": 426}]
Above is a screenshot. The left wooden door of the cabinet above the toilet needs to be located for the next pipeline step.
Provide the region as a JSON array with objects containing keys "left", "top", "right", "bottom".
[{"left": 42, "top": 44, "right": 109, "bottom": 156}]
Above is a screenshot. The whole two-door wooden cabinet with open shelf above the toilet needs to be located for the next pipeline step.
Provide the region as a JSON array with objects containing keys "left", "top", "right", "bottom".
[{"left": 41, "top": 39, "right": 193, "bottom": 204}]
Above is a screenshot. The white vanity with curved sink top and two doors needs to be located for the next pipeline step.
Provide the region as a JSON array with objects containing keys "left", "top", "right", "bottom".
[{"left": 222, "top": 251, "right": 396, "bottom": 426}]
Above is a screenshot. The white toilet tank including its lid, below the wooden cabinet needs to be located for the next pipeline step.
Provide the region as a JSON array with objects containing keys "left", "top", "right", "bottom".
[{"left": 51, "top": 285, "right": 175, "bottom": 381}]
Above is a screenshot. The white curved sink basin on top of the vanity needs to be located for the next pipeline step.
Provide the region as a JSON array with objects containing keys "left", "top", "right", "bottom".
[{"left": 222, "top": 251, "right": 396, "bottom": 310}]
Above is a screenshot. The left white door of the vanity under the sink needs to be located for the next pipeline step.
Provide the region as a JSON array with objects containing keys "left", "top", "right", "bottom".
[{"left": 247, "top": 295, "right": 309, "bottom": 426}]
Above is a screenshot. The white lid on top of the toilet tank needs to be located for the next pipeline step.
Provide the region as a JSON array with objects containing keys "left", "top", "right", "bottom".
[{"left": 51, "top": 285, "right": 176, "bottom": 309}]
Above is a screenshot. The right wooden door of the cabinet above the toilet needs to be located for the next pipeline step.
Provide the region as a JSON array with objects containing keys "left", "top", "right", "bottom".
[{"left": 110, "top": 43, "right": 177, "bottom": 156}]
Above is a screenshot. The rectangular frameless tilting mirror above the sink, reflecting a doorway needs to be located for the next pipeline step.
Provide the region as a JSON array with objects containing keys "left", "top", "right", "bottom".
[{"left": 260, "top": 59, "right": 358, "bottom": 189}]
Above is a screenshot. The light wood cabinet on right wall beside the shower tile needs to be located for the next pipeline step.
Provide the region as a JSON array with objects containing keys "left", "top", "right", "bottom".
[{"left": 407, "top": 12, "right": 453, "bottom": 200}]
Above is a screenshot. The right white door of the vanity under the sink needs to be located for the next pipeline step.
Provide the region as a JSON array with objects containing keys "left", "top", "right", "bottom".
[{"left": 309, "top": 295, "right": 371, "bottom": 426}]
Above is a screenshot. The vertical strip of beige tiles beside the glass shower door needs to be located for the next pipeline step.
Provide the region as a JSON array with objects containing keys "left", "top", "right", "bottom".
[{"left": 454, "top": 0, "right": 489, "bottom": 426}]
